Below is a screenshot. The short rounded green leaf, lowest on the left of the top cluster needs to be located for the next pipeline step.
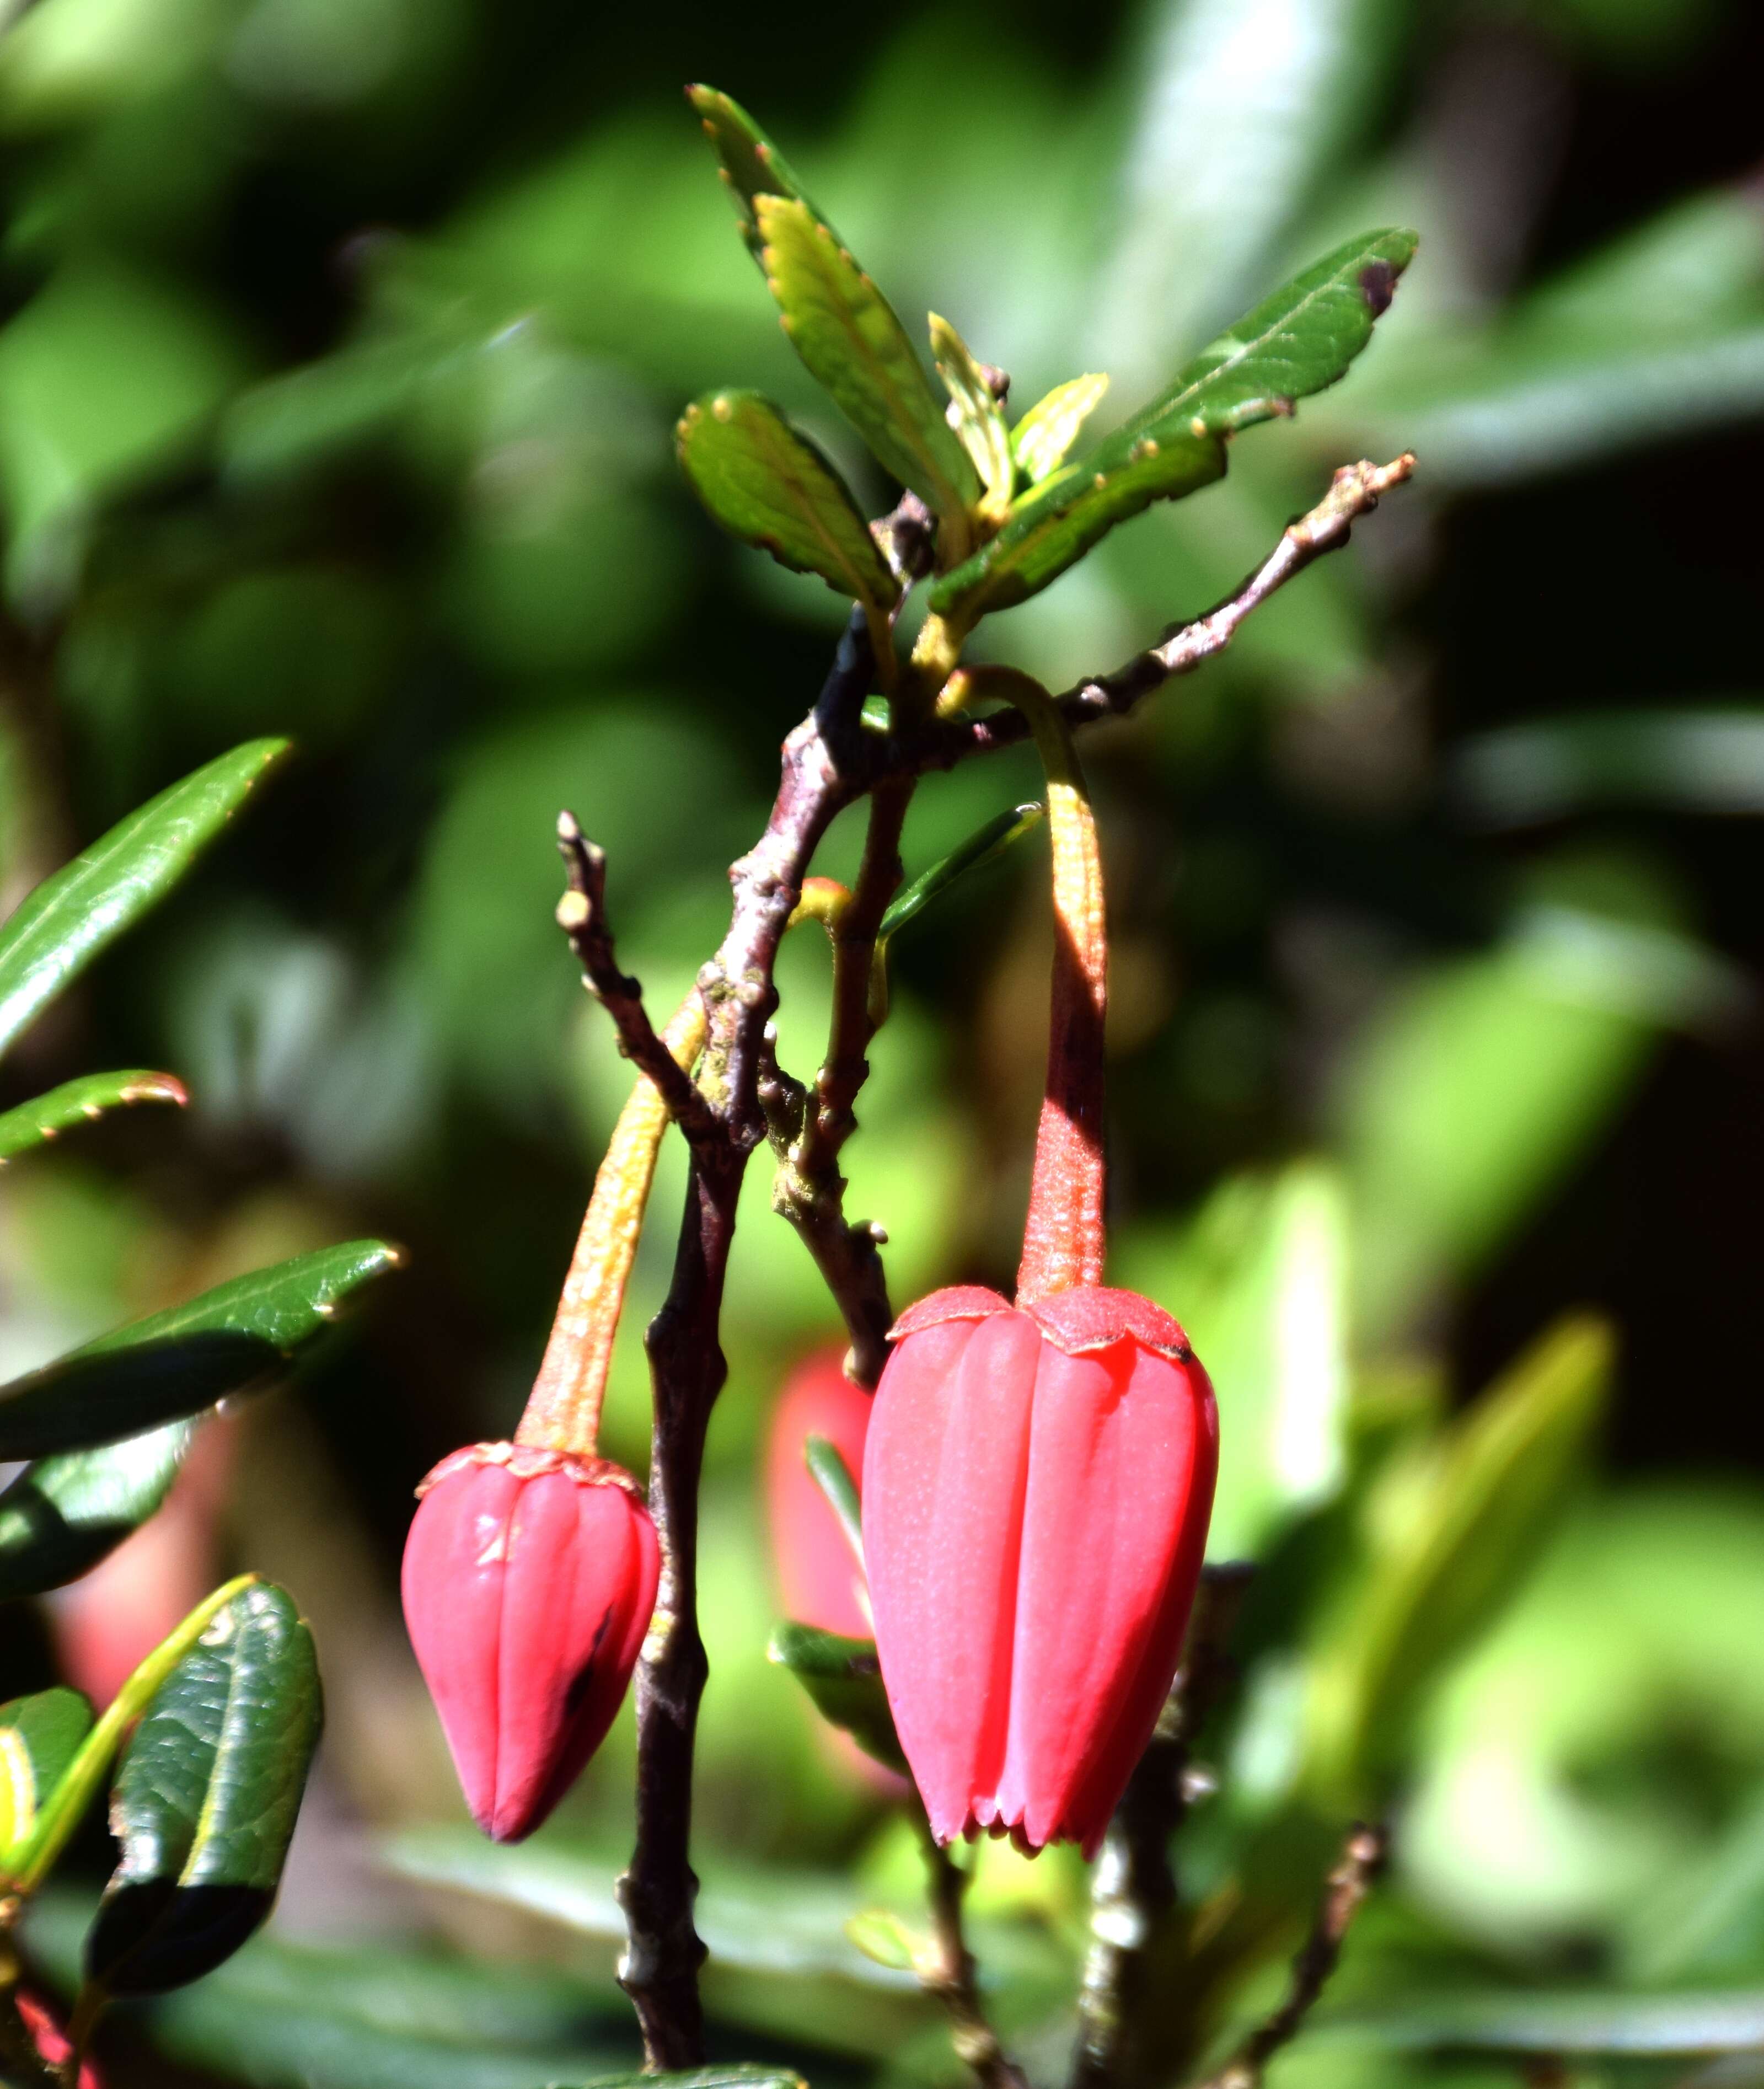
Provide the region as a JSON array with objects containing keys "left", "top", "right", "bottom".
[{"left": 674, "top": 390, "right": 900, "bottom": 616}]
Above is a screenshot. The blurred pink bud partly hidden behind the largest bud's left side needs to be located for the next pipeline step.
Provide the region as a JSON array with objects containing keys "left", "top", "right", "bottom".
[{"left": 766, "top": 1349, "right": 872, "bottom": 1640}]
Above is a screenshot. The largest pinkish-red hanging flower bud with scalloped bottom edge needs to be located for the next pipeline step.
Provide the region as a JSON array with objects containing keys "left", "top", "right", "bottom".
[{"left": 864, "top": 1285, "right": 1219, "bottom": 1855}]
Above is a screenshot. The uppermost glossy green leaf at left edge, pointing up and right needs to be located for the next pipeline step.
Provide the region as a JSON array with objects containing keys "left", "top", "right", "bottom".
[{"left": 0, "top": 740, "right": 288, "bottom": 1051}]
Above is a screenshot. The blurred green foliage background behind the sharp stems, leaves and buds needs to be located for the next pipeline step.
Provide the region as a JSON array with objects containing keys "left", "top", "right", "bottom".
[{"left": 0, "top": 0, "right": 1764, "bottom": 2085}]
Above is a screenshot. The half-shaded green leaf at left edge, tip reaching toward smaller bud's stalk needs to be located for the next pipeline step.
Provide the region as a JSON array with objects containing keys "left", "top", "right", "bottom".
[{"left": 0, "top": 1241, "right": 399, "bottom": 1458}]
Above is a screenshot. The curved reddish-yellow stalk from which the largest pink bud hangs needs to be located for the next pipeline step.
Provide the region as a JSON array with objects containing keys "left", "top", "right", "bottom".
[{"left": 1010, "top": 685, "right": 1108, "bottom": 1299}]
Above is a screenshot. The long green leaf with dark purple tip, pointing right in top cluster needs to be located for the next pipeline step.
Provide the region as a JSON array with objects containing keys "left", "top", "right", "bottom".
[{"left": 931, "top": 230, "right": 1416, "bottom": 623}]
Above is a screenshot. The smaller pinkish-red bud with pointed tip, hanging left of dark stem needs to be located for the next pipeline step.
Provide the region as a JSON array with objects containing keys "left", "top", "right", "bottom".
[{"left": 403, "top": 1444, "right": 660, "bottom": 1842}]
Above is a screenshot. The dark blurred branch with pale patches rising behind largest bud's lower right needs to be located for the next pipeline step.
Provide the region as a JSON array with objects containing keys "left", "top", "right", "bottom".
[{"left": 1071, "top": 1562, "right": 1254, "bottom": 2089}]
